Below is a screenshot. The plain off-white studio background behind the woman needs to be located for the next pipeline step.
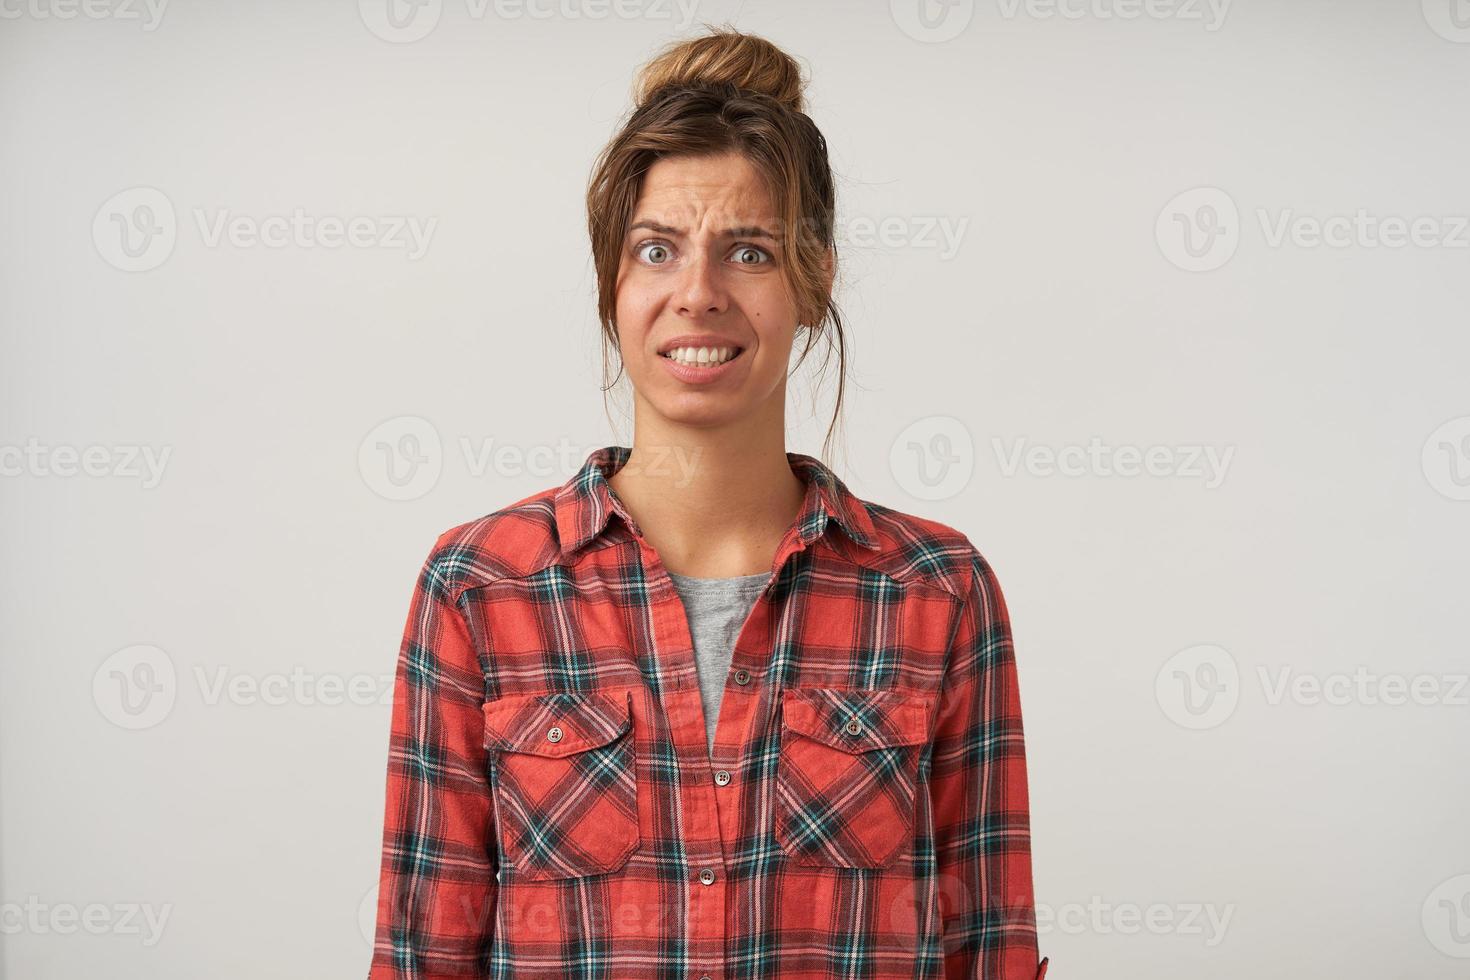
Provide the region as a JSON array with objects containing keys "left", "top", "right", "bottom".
[{"left": 0, "top": 0, "right": 1470, "bottom": 980}]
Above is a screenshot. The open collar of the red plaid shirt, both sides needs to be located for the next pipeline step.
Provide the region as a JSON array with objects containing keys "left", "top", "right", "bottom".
[{"left": 554, "top": 445, "right": 879, "bottom": 554}]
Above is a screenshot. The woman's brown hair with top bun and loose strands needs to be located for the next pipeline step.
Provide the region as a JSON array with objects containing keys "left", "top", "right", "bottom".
[{"left": 587, "top": 26, "right": 847, "bottom": 461}]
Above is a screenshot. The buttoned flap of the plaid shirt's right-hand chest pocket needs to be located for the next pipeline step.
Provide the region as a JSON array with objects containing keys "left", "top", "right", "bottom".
[{"left": 781, "top": 688, "right": 933, "bottom": 752}]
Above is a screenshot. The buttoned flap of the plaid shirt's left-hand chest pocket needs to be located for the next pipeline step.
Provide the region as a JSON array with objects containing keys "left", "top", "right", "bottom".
[{"left": 484, "top": 691, "right": 634, "bottom": 758}]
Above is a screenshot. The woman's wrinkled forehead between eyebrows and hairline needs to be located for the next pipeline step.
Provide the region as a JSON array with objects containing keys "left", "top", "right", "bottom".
[{"left": 634, "top": 153, "right": 775, "bottom": 220}]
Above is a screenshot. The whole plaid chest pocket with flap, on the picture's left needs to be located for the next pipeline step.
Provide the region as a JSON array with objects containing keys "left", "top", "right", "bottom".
[{"left": 484, "top": 691, "right": 641, "bottom": 879}]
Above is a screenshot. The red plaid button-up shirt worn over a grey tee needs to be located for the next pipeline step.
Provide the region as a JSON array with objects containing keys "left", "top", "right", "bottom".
[{"left": 369, "top": 445, "right": 1047, "bottom": 980}]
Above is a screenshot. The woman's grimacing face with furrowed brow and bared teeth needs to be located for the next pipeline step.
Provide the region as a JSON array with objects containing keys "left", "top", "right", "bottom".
[{"left": 616, "top": 153, "right": 817, "bottom": 426}]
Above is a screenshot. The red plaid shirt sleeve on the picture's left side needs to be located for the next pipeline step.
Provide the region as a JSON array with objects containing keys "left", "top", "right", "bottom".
[{"left": 368, "top": 536, "right": 497, "bottom": 980}]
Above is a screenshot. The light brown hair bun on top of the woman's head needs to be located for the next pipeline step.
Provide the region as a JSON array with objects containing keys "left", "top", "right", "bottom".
[{"left": 635, "top": 28, "right": 806, "bottom": 112}]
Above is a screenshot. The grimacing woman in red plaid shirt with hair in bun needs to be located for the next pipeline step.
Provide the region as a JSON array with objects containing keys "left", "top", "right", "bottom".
[{"left": 370, "top": 29, "right": 1047, "bottom": 980}]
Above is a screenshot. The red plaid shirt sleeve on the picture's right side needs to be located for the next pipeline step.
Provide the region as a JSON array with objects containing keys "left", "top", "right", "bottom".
[{"left": 929, "top": 545, "right": 1047, "bottom": 980}]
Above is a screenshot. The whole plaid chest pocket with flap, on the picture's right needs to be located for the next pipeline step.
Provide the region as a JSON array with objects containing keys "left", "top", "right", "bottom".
[{"left": 775, "top": 688, "right": 931, "bottom": 868}]
